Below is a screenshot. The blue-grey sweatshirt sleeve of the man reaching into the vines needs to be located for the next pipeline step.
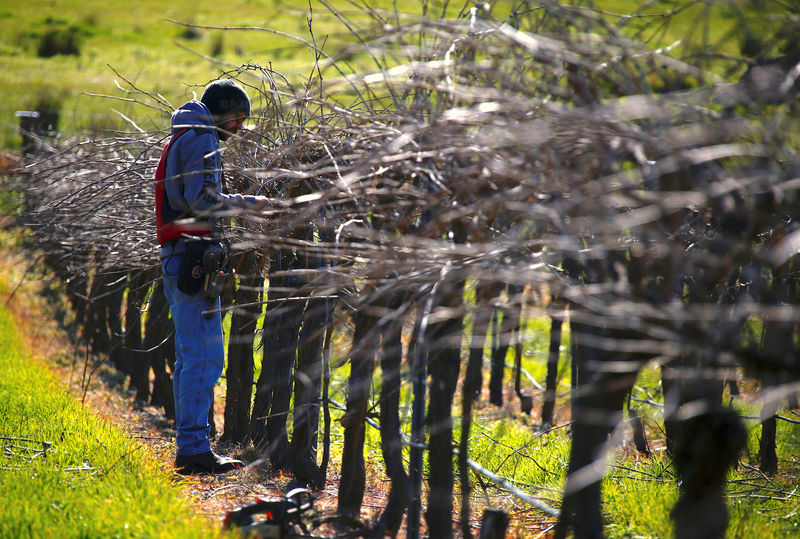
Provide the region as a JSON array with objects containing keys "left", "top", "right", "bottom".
[{"left": 167, "top": 132, "right": 256, "bottom": 216}]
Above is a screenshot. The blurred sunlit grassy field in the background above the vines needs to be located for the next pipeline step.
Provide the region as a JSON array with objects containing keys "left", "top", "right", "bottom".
[{"left": 0, "top": 0, "right": 774, "bottom": 148}]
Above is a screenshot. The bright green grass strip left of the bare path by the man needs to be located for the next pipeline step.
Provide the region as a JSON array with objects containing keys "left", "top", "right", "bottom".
[{"left": 0, "top": 302, "right": 220, "bottom": 538}]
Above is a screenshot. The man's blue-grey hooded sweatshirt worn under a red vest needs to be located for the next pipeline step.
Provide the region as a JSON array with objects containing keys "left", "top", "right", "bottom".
[{"left": 162, "top": 100, "right": 256, "bottom": 255}]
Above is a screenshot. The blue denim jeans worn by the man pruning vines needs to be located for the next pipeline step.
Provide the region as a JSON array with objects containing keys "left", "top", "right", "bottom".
[{"left": 161, "top": 249, "right": 225, "bottom": 455}]
